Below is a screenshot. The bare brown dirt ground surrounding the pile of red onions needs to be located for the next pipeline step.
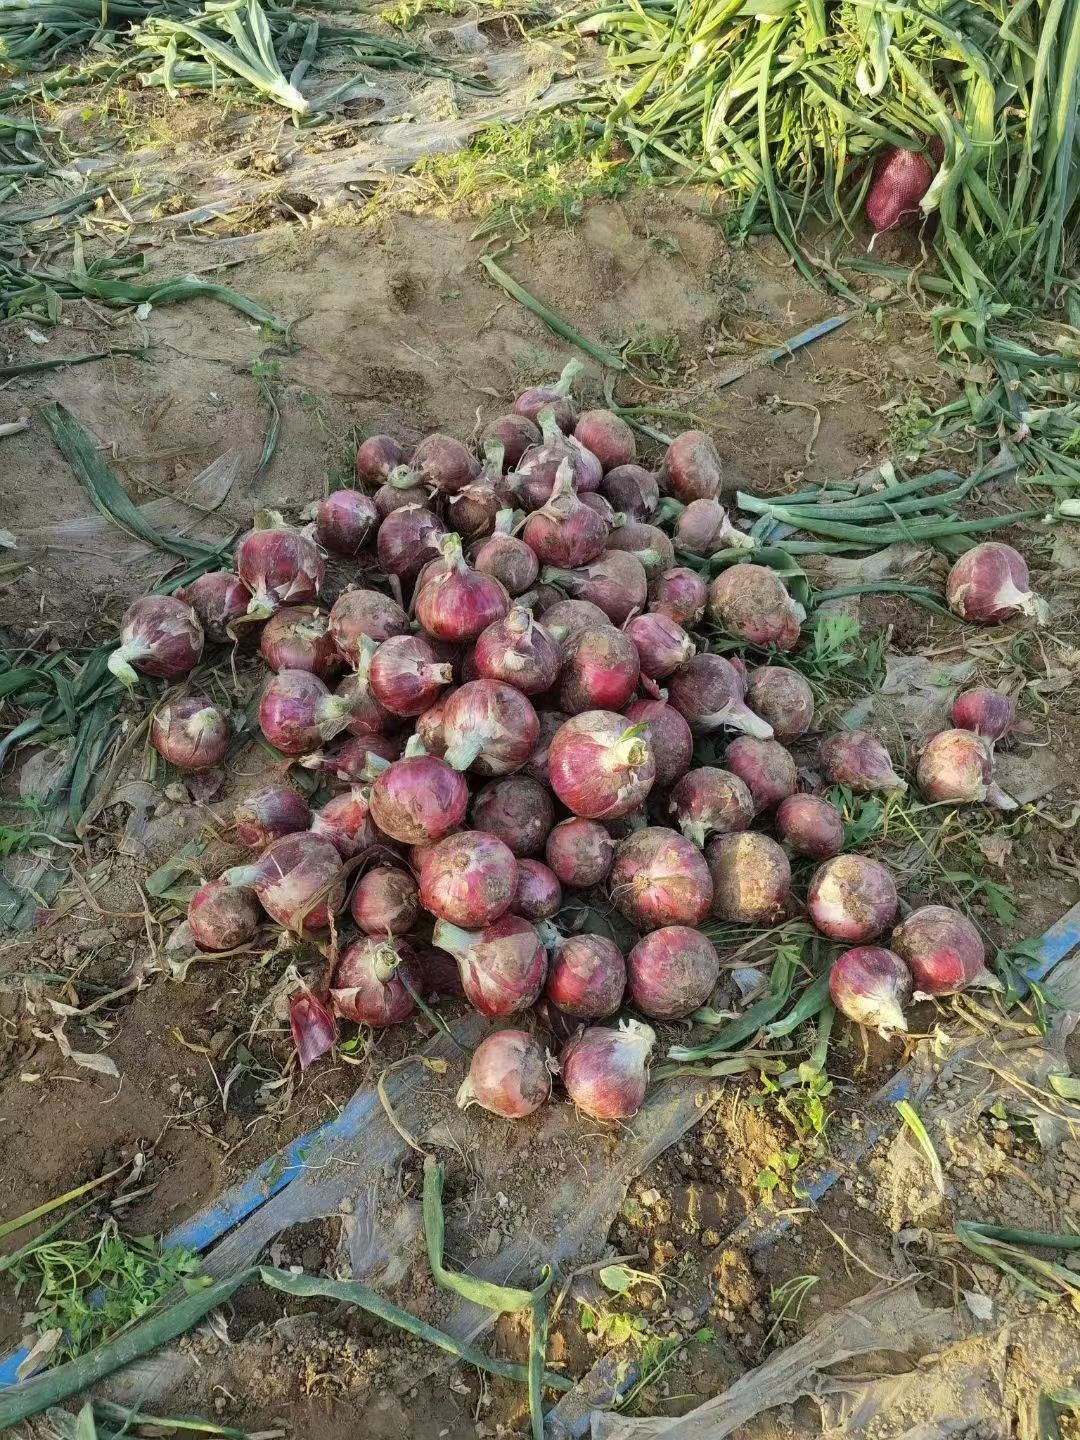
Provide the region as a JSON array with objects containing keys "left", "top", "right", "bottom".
[{"left": 0, "top": 160, "right": 1080, "bottom": 1440}]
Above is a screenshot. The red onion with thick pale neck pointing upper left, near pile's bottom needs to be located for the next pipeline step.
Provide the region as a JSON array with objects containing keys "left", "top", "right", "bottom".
[{"left": 432, "top": 914, "right": 547, "bottom": 1020}]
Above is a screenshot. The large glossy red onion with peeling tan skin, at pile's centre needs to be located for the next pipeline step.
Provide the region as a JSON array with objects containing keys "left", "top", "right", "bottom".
[{"left": 547, "top": 710, "right": 655, "bottom": 823}]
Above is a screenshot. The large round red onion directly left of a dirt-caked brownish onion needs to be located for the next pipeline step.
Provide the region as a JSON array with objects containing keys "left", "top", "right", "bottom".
[{"left": 608, "top": 825, "right": 713, "bottom": 930}]
